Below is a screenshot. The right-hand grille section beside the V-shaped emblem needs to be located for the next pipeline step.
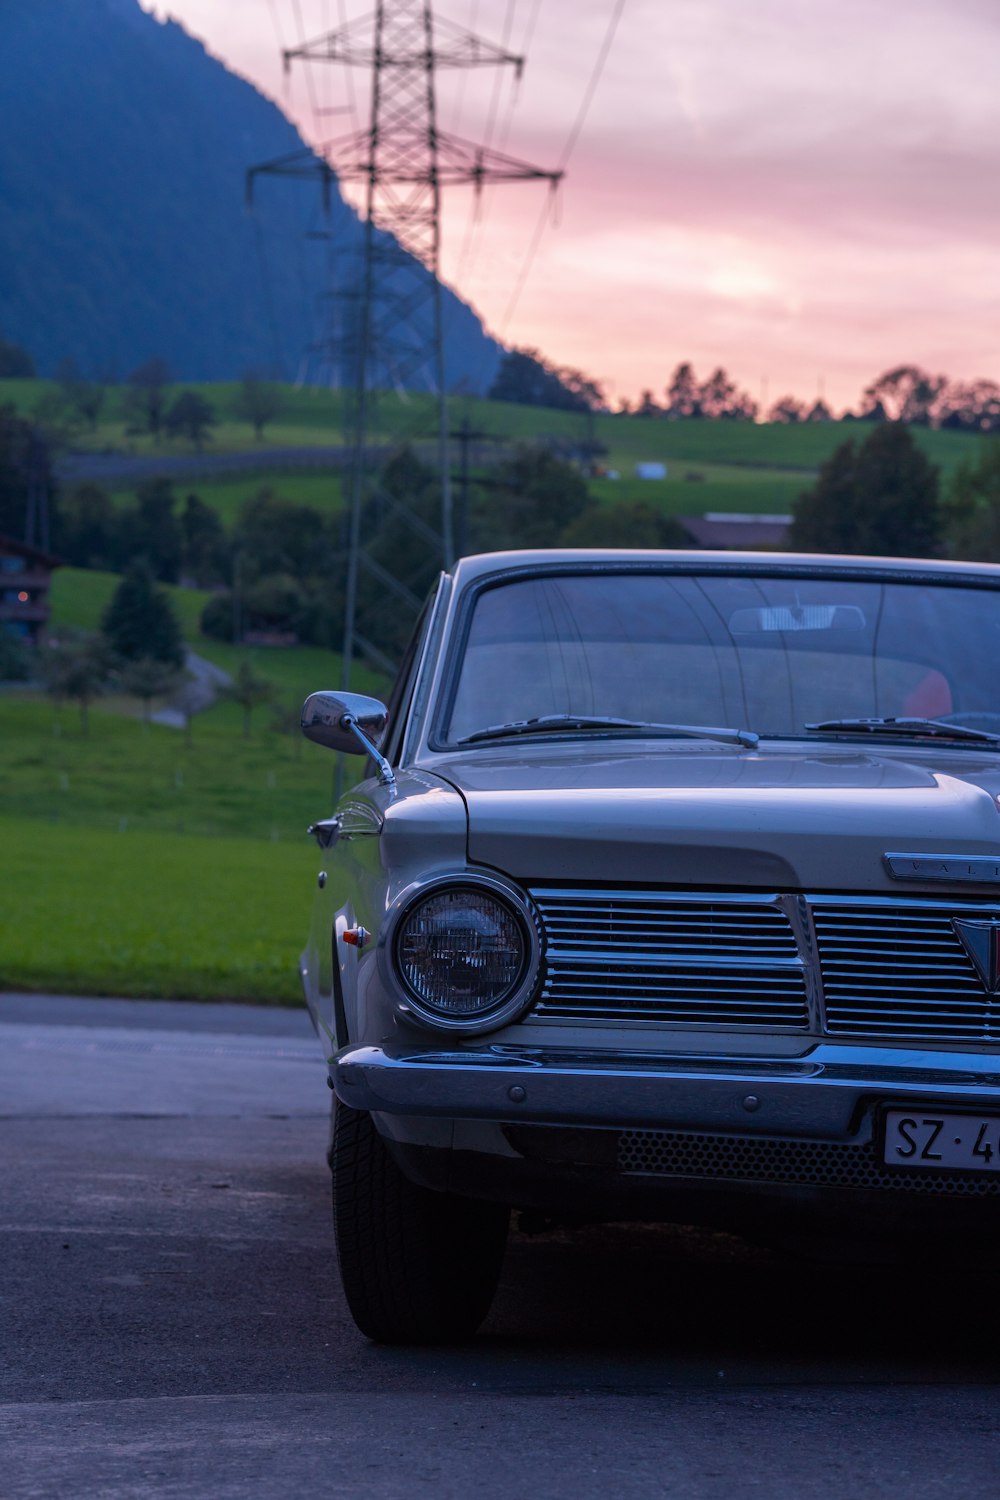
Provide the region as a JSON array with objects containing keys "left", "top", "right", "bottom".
[{"left": 813, "top": 897, "right": 1000, "bottom": 1041}]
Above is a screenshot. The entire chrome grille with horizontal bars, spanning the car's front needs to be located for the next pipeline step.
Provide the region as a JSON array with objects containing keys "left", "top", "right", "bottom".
[{"left": 531, "top": 887, "right": 1000, "bottom": 1044}]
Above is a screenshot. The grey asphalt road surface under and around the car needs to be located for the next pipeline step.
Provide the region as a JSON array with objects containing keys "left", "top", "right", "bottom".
[{"left": 0, "top": 996, "right": 1000, "bottom": 1500}]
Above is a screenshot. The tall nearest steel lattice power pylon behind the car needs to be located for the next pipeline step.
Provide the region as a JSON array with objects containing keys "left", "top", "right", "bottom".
[{"left": 249, "top": 0, "right": 562, "bottom": 689}]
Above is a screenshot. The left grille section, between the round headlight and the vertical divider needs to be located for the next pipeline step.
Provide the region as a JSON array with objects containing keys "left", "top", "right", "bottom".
[{"left": 531, "top": 890, "right": 808, "bottom": 1029}]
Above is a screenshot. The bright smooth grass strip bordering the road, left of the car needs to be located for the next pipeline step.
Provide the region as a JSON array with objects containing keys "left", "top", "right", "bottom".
[{"left": 0, "top": 816, "right": 316, "bottom": 1005}]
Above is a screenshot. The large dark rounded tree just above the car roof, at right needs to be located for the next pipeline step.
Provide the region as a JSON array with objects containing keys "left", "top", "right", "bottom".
[{"left": 790, "top": 422, "right": 942, "bottom": 557}]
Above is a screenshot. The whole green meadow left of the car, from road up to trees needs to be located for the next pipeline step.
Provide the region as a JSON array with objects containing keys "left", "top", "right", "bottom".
[{"left": 0, "top": 569, "right": 387, "bottom": 1004}]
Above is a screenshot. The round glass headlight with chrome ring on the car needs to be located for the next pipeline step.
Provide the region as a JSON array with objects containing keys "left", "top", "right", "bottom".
[{"left": 393, "top": 882, "right": 540, "bottom": 1032}]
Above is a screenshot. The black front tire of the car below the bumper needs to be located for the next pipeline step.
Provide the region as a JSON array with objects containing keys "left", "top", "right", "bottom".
[{"left": 330, "top": 1101, "right": 510, "bottom": 1344}]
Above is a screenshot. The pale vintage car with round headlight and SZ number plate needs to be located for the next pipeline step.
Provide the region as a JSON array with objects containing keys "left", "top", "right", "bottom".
[{"left": 301, "top": 551, "right": 1000, "bottom": 1341}]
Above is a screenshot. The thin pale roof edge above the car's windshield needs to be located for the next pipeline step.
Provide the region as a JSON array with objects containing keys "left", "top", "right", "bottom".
[{"left": 451, "top": 548, "right": 1000, "bottom": 587}]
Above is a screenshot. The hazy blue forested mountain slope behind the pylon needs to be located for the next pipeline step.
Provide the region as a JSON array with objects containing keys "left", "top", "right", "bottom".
[{"left": 0, "top": 0, "right": 498, "bottom": 389}]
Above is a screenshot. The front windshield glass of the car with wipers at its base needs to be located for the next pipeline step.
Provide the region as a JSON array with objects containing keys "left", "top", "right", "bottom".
[{"left": 444, "top": 572, "right": 1000, "bottom": 744}]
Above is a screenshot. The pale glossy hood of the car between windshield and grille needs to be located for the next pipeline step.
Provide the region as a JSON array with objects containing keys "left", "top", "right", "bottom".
[{"left": 435, "top": 741, "right": 1000, "bottom": 896}]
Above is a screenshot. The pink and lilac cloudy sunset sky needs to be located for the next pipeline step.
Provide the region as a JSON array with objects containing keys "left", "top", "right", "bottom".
[{"left": 142, "top": 0, "right": 1000, "bottom": 410}]
